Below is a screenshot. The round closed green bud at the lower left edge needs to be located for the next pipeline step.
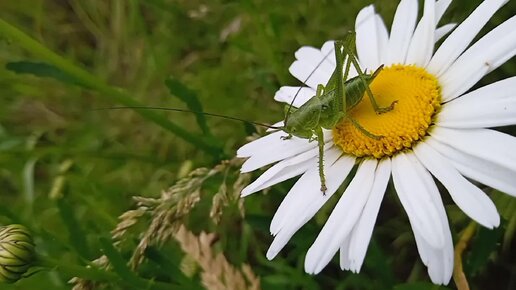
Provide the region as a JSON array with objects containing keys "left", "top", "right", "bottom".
[{"left": 0, "top": 225, "right": 35, "bottom": 283}]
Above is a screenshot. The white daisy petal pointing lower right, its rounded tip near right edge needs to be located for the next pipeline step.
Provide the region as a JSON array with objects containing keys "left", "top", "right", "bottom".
[{"left": 414, "top": 142, "right": 500, "bottom": 228}]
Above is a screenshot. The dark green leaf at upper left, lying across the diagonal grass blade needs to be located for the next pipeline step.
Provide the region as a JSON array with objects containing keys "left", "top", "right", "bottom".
[{"left": 5, "top": 61, "right": 84, "bottom": 86}]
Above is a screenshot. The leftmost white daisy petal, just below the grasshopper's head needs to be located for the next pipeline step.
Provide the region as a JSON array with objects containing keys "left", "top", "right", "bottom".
[{"left": 237, "top": 131, "right": 331, "bottom": 172}]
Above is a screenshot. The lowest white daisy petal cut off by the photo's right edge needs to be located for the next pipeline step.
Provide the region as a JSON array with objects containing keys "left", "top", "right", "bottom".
[{"left": 426, "top": 138, "right": 516, "bottom": 196}]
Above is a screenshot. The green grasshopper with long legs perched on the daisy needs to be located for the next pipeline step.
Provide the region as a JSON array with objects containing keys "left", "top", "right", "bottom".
[{"left": 279, "top": 32, "right": 396, "bottom": 193}]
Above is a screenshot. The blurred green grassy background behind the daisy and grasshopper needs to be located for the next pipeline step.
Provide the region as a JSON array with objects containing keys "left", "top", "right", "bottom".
[{"left": 0, "top": 0, "right": 516, "bottom": 290}]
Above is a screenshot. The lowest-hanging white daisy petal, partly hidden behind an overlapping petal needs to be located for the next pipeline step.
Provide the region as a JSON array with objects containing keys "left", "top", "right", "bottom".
[{"left": 407, "top": 154, "right": 453, "bottom": 284}]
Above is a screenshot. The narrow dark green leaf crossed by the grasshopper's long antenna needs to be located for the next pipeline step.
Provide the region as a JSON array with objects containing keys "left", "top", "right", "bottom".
[{"left": 165, "top": 77, "right": 212, "bottom": 136}]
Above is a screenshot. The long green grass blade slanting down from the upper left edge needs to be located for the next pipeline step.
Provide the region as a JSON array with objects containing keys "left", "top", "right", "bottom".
[{"left": 0, "top": 18, "right": 221, "bottom": 156}]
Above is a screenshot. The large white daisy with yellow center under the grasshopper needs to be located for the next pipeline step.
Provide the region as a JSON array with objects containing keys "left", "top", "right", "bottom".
[{"left": 237, "top": 0, "right": 516, "bottom": 284}]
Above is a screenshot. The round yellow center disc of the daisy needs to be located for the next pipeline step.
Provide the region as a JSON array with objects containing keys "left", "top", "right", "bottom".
[{"left": 333, "top": 65, "right": 441, "bottom": 159}]
